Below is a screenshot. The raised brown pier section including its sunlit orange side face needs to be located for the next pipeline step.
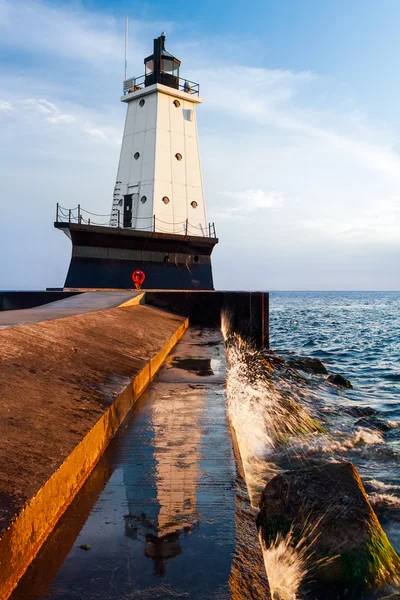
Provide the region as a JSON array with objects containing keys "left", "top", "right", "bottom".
[{"left": 0, "top": 300, "right": 187, "bottom": 599}]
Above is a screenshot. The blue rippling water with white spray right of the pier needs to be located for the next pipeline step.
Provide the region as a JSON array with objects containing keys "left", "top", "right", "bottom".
[{"left": 223, "top": 292, "right": 400, "bottom": 600}]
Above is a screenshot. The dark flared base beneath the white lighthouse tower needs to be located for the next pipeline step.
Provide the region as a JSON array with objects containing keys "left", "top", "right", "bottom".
[{"left": 54, "top": 222, "right": 218, "bottom": 290}]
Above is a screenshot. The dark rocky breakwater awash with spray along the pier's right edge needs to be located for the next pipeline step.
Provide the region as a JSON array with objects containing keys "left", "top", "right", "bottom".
[{"left": 223, "top": 336, "right": 400, "bottom": 600}]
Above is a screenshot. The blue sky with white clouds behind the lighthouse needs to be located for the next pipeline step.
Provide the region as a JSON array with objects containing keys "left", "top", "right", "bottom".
[{"left": 0, "top": 0, "right": 400, "bottom": 290}]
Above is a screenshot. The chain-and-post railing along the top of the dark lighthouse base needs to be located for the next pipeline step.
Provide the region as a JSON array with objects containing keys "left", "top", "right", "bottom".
[{"left": 56, "top": 202, "right": 217, "bottom": 238}]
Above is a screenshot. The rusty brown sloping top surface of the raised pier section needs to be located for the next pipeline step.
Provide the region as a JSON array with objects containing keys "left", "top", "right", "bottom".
[{"left": 0, "top": 306, "right": 185, "bottom": 536}]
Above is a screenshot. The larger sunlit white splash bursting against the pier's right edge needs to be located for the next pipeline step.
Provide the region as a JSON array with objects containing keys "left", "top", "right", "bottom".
[{"left": 226, "top": 336, "right": 321, "bottom": 506}]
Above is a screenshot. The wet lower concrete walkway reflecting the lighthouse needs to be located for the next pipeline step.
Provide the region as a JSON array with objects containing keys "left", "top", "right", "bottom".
[{"left": 12, "top": 329, "right": 253, "bottom": 600}]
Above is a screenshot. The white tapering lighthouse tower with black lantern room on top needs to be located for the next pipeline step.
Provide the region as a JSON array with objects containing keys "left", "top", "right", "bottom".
[{"left": 110, "top": 35, "right": 210, "bottom": 236}]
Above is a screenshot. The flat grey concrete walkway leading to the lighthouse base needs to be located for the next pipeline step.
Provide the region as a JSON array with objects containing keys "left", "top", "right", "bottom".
[{"left": 0, "top": 291, "right": 138, "bottom": 329}]
